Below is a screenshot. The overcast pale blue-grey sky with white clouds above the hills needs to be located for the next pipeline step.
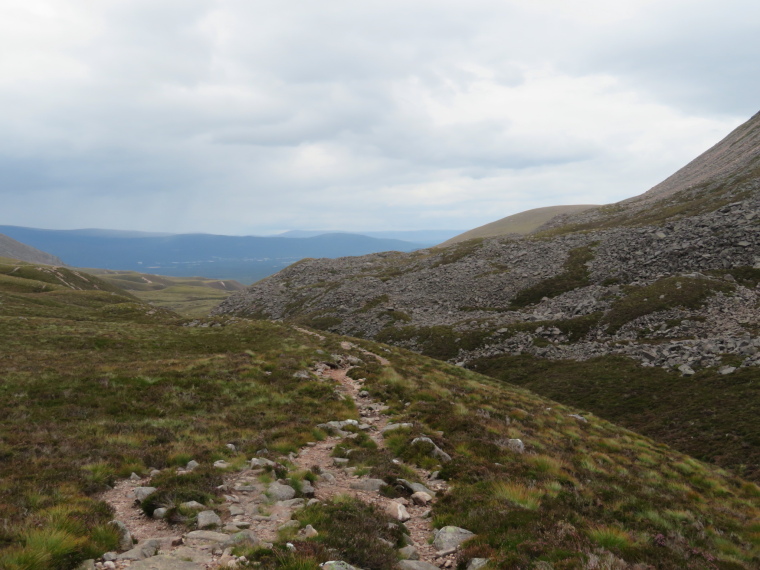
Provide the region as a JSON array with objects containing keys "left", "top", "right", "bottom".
[{"left": 0, "top": 0, "right": 760, "bottom": 235}]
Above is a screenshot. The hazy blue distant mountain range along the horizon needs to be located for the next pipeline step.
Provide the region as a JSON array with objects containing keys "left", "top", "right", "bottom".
[{"left": 0, "top": 226, "right": 425, "bottom": 283}]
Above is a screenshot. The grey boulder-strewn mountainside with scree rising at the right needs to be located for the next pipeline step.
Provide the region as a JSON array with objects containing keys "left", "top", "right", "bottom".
[{"left": 215, "top": 108, "right": 760, "bottom": 476}]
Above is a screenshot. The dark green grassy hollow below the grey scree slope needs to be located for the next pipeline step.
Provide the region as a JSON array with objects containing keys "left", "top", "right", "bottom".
[{"left": 470, "top": 355, "right": 760, "bottom": 481}]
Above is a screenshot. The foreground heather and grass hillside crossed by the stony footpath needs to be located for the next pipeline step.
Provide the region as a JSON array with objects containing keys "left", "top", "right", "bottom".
[{"left": 0, "top": 263, "right": 760, "bottom": 570}]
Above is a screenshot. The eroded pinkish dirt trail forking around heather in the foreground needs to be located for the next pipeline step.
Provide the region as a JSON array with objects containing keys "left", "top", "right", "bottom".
[{"left": 95, "top": 340, "right": 453, "bottom": 570}]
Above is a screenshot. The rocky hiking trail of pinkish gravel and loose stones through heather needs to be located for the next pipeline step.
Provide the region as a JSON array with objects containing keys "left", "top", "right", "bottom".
[{"left": 92, "top": 336, "right": 478, "bottom": 570}]
